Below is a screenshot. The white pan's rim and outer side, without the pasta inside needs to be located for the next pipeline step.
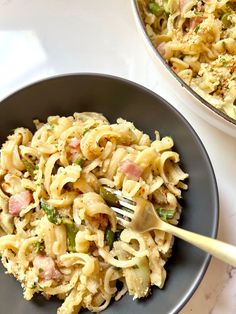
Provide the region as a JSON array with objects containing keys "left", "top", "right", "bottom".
[{"left": 132, "top": 0, "right": 236, "bottom": 137}]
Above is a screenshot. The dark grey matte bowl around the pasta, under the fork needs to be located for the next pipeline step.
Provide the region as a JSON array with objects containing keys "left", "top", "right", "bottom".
[{"left": 0, "top": 74, "right": 218, "bottom": 314}]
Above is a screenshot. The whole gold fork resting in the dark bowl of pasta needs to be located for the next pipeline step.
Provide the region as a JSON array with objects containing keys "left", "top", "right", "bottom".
[{"left": 104, "top": 187, "right": 236, "bottom": 266}]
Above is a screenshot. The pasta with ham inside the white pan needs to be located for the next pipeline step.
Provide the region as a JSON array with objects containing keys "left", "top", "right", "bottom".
[{"left": 138, "top": 0, "right": 236, "bottom": 119}]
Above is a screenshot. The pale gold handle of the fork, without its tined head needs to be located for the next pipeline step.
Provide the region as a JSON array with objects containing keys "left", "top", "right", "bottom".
[{"left": 161, "top": 222, "right": 236, "bottom": 266}]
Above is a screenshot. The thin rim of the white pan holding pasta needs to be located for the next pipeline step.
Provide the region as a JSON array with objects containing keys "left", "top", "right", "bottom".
[{"left": 131, "top": 0, "right": 236, "bottom": 126}]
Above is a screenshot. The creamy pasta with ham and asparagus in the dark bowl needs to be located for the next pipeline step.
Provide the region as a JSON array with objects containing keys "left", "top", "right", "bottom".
[{"left": 0, "top": 112, "right": 188, "bottom": 314}]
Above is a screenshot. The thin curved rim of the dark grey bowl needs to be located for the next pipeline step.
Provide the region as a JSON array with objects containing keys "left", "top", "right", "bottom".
[{"left": 0, "top": 73, "right": 220, "bottom": 314}]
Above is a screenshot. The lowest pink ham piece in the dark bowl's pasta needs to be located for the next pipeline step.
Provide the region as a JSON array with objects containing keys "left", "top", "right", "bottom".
[{"left": 33, "top": 255, "right": 61, "bottom": 280}]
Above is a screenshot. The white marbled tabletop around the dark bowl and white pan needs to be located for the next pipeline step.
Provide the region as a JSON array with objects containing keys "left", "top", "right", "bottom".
[{"left": 0, "top": 0, "right": 236, "bottom": 314}]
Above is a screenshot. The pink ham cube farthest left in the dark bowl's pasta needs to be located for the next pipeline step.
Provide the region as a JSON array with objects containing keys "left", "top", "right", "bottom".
[{"left": 9, "top": 191, "right": 32, "bottom": 216}]
